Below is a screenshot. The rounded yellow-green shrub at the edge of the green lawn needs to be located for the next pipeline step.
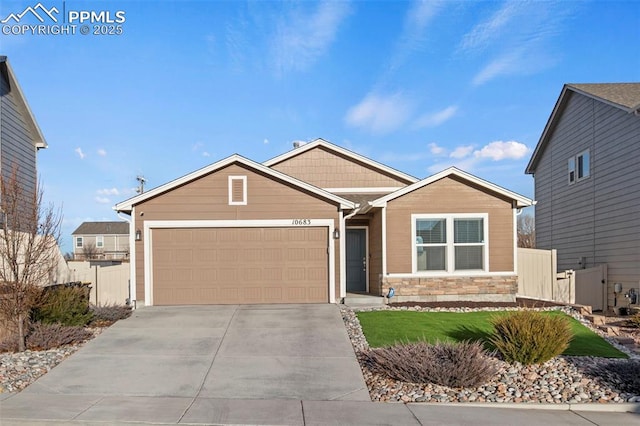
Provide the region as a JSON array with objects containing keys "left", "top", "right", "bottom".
[{"left": 489, "top": 310, "right": 573, "bottom": 365}]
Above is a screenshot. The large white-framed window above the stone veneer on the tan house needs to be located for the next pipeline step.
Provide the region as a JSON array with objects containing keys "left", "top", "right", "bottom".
[{"left": 412, "top": 213, "right": 488, "bottom": 273}]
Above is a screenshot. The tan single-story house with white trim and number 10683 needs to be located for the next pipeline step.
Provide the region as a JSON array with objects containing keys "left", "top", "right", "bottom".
[{"left": 115, "top": 139, "right": 533, "bottom": 305}]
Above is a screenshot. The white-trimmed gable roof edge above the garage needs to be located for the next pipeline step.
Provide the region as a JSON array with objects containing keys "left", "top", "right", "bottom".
[{"left": 114, "top": 154, "right": 356, "bottom": 213}]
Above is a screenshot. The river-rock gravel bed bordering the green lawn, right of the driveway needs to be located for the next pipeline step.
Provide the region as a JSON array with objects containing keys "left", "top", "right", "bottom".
[{"left": 341, "top": 305, "right": 640, "bottom": 404}]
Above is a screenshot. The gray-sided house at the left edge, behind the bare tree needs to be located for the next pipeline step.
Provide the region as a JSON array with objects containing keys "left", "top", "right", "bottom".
[{"left": 0, "top": 56, "right": 47, "bottom": 200}]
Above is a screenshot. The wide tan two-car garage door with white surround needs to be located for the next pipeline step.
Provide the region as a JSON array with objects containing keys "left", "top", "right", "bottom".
[{"left": 151, "top": 227, "right": 329, "bottom": 305}]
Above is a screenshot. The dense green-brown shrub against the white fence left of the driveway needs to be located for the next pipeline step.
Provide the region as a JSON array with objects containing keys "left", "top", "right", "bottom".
[{"left": 32, "top": 286, "right": 93, "bottom": 326}]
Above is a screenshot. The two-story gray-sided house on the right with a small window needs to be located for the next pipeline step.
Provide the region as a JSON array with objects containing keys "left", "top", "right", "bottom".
[{"left": 526, "top": 83, "right": 640, "bottom": 306}]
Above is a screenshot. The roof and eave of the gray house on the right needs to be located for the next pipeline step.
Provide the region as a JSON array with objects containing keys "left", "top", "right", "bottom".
[{"left": 525, "top": 83, "right": 640, "bottom": 174}]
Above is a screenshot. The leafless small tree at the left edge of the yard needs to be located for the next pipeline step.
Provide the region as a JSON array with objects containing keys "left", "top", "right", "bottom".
[{"left": 0, "top": 168, "right": 62, "bottom": 352}]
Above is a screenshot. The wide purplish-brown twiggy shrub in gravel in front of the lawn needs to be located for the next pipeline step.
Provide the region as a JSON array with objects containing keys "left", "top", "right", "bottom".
[{"left": 365, "top": 341, "right": 498, "bottom": 388}]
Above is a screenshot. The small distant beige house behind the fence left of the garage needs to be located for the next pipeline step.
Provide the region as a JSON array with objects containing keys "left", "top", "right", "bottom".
[{"left": 71, "top": 221, "right": 129, "bottom": 260}]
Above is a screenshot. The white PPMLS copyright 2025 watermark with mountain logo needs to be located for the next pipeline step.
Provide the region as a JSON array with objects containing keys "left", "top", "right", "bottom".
[{"left": 0, "top": 1, "right": 127, "bottom": 36}]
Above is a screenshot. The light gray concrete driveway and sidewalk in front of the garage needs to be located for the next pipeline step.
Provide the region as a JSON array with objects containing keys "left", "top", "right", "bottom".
[{"left": 0, "top": 305, "right": 640, "bottom": 426}]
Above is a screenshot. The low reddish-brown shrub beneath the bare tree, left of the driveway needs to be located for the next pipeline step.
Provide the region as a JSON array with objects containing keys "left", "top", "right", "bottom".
[{"left": 0, "top": 323, "right": 93, "bottom": 352}]
